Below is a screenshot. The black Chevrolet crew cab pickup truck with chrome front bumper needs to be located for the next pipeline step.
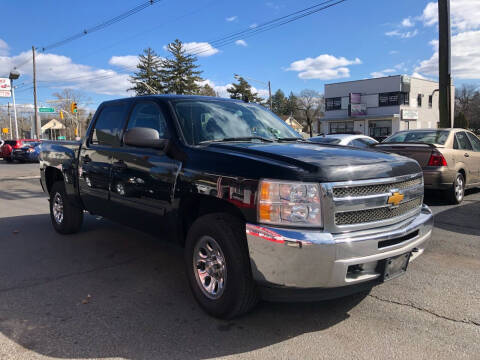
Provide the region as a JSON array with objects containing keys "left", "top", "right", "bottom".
[{"left": 40, "top": 95, "right": 433, "bottom": 318}]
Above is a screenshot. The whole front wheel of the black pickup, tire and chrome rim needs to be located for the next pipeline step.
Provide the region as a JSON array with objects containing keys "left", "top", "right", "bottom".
[{"left": 185, "top": 213, "right": 257, "bottom": 319}]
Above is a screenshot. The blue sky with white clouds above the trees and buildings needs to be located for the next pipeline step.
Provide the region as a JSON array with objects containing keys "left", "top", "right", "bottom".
[{"left": 0, "top": 0, "right": 480, "bottom": 107}]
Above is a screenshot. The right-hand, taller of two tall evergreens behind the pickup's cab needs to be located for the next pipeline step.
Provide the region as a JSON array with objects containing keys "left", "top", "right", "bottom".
[{"left": 160, "top": 39, "right": 202, "bottom": 95}]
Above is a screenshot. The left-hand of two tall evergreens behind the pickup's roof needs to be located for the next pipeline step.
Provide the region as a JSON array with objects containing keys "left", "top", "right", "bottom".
[{"left": 128, "top": 48, "right": 165, "bottom": 96}]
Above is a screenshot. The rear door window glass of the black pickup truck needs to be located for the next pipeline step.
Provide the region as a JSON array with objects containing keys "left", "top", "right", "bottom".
[{"left": 90, "top": 102, "right": 128, "bottom": 146}]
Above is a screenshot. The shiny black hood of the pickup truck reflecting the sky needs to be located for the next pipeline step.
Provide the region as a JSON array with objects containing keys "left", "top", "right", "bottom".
[{"left": 204, "top": 142, "right": 422, "bottom": 182}]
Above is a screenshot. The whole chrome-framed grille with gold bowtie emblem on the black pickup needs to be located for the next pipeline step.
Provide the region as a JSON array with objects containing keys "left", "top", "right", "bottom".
[{"left": 322, "top": 173, "right": 424, "bottom": 233}]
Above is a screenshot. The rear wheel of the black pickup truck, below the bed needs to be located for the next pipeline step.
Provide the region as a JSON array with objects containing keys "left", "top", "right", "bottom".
[{"left": 50, "top": 181, "right": 83, "bottom": 234}]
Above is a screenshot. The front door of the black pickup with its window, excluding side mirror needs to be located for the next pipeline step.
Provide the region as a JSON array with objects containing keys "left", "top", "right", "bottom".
[{"left": 110, "top": 100, "right": 181, "bottom": 233}]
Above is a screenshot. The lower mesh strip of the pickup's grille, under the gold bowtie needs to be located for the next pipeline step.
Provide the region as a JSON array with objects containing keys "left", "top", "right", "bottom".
[{"left": 335, "top": 198, "right": 423, "bottom": 225}]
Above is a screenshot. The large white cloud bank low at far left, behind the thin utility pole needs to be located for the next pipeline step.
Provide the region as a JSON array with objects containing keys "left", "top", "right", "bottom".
[{"left": 0, "top": 51, "right": 131, "bottom": 96}]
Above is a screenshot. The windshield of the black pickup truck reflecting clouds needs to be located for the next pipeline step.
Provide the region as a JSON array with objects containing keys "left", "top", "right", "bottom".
[{"left": 173, "top": 100, "right": 302, "bottom": 145}]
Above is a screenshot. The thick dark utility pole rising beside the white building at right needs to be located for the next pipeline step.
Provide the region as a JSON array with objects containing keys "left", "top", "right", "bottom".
[{"left": 438, "top": 0, "right": 453, "bottom": 128}]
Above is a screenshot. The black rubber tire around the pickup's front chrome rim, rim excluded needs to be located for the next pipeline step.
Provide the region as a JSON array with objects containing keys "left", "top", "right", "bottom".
[{"left": 185, "top": 213, "right": 258, "bottom": 319}]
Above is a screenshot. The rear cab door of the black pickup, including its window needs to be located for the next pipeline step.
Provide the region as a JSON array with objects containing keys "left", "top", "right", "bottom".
[{"left": 78, "top": 101, "right": 128, "bottom": 217}]
